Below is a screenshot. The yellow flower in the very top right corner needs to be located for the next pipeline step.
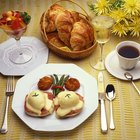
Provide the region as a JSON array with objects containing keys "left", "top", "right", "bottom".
[{"left": 123, "top": 0, "right": 140, "bottom": 15}]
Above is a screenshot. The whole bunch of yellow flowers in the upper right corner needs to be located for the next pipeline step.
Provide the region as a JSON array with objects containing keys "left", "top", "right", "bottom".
[{"left": 88, "top": 0, "right": 140, "bottom": 37}]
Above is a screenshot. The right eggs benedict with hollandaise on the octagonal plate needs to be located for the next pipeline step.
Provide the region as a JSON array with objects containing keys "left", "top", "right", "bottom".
[{"left": 54, "top": 91, "right": 84, "bottom": 118}]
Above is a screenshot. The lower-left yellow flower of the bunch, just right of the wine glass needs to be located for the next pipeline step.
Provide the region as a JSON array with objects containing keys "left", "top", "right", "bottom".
[{"left": 112, "top": 23, "right": 128, "bottom": 37}]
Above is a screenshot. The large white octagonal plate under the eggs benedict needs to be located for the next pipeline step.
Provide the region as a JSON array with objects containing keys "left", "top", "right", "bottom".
[{"left": 12, "top": 64, "right": 98, "bottom": 132}]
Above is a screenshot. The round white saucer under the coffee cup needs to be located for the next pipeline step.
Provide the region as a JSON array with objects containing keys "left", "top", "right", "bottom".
[{"left": 105, "top": 51, "right": 140, "bottom": 80}]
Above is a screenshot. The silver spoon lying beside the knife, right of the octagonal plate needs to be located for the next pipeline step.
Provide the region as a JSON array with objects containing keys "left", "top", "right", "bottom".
[{"left": 106, "top": 84, "right": 116, "bottom": 129}]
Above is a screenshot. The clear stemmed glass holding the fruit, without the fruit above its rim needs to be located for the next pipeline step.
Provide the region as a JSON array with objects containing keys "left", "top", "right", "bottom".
[{"left": 3, "top": 25, "right": 32, "bottom": 64}]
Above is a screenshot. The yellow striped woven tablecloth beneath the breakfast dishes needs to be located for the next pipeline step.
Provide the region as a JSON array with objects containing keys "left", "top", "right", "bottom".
[{"left": 0, "top": 0, "right": 140, "bottom": 140}]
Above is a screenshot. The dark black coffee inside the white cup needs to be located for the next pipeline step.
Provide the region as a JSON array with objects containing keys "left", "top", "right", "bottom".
[{"left": 118, "top": 46, "right": 140, "bottom": 58}]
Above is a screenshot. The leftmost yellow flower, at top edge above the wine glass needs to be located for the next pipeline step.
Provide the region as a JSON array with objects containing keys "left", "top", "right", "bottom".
[{"left": 95, "top": 0, "right": 110, "bottom": 15}]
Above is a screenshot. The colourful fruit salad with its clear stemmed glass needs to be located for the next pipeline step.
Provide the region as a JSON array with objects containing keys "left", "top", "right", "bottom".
[{"left": 0, "top": 11, "right": 32, "bottom": 64}]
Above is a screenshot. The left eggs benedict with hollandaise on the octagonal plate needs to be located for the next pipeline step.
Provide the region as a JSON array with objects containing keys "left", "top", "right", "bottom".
[{"left": 24, "top": 90, "right": 54, "bottom": 117}]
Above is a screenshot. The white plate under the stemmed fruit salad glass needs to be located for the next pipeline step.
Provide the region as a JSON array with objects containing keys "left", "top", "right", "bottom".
[{"left": 0, "top": 37, "right": 49, "bottom": 76}]
